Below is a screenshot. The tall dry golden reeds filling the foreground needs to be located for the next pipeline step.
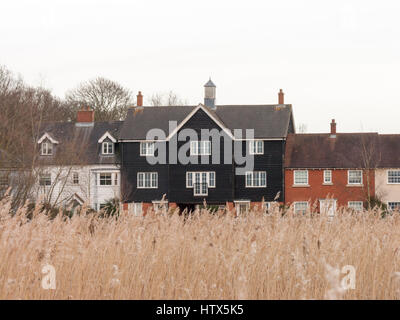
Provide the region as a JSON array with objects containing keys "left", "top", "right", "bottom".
[{"left": 0, "top": 199, "right": 400, "bottom": 299}]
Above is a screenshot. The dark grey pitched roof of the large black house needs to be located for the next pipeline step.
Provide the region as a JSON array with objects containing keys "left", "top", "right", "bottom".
[{"left": 119, "top": 105, "right": 292, "bottom": 140}]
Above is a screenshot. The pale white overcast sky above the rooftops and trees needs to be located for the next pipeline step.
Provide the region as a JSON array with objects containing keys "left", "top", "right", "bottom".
[{"left": 0, "top": 0, "right": 400, "bottom": 133}]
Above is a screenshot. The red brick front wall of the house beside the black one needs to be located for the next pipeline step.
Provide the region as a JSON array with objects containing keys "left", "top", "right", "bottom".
[{"left": 285, "top": 169, "right": 375, "bottom": 207}]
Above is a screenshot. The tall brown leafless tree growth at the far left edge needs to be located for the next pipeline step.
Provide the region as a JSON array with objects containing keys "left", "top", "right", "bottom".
[{"left": 0, "top": 66, "right": 74, "bottom": 207}]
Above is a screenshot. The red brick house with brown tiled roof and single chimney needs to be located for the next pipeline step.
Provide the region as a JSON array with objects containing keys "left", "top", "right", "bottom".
[{"left": 285, "top": 120, "right": 379, "bottom": 214}]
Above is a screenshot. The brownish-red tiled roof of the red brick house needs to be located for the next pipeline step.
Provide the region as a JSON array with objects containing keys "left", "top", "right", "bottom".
[{"left": 285, "top": 133, "right": 381, "bottom": 169}]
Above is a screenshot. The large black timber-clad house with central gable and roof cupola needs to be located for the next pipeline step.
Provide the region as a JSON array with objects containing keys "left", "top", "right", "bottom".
[{"left": 119, "top": 80, "right": 295, "bottom": 212}]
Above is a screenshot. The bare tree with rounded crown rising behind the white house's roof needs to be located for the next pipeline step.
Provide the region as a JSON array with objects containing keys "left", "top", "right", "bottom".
[{"left": 66, "top": 77, "right": 133, "bottom": 121}]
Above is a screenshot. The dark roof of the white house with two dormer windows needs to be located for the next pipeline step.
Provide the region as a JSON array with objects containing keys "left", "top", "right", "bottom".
[{"left": 40, "top": 121, "right": 123, "bottom": 164}]
